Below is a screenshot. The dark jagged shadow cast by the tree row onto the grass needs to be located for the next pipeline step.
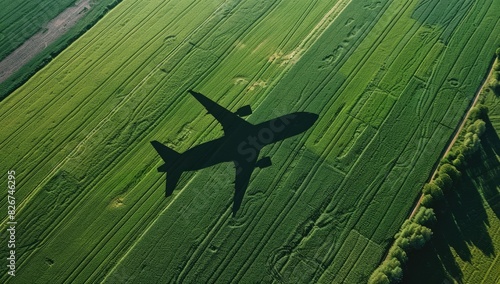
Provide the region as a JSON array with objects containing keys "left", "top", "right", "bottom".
[{"left": 403, "top": 115, "right": 500, "bottom": 283}]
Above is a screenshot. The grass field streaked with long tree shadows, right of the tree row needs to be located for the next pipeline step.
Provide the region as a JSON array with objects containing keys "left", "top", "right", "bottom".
[{"left": 404, "top": 85, "right": 500, "bottom": 283}]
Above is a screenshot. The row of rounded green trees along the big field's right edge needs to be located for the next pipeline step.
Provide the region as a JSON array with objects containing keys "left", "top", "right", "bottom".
[{"left": 368, "top": 104, "right": 488, "bottom": 284}]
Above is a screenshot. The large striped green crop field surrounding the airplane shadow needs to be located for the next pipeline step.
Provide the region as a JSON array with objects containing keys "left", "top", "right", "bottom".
[{"left": 0, "top": 0, "right": 500, "bottom": 283}]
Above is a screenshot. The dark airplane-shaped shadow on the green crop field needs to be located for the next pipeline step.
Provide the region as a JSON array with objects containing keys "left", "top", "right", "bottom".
[{"left": 151, "top": 90, "right": 319, "bottom": 216}]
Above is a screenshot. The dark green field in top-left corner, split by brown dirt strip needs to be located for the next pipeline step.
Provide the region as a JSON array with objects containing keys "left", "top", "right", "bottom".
[{"left": 0, "top": 0, "right": 119, "bottom": 100}]
